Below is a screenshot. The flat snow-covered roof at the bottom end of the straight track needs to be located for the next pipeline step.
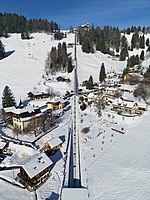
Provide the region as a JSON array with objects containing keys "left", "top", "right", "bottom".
[{"left": 62, "top": 188, "right": 88, "bottom": 200}]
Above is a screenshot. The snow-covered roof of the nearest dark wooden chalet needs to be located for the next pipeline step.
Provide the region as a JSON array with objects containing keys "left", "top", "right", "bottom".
[{"left": 22, "top": 153, "right": 53, "bottom": 179}]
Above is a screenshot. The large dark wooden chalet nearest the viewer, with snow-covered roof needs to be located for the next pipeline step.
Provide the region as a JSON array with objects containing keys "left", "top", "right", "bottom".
[{"left": 18, "top": 153, "right": 53, "bottom": 191}]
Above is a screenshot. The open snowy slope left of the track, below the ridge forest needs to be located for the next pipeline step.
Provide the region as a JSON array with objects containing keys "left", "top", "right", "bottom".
[{"left": 0, "top": 33, "right": 73, "bottom": 104}]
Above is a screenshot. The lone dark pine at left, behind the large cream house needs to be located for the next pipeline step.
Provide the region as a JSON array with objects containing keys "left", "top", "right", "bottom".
[{"left": 2, "top": 86, "right": 16, "bottom": 108}]
